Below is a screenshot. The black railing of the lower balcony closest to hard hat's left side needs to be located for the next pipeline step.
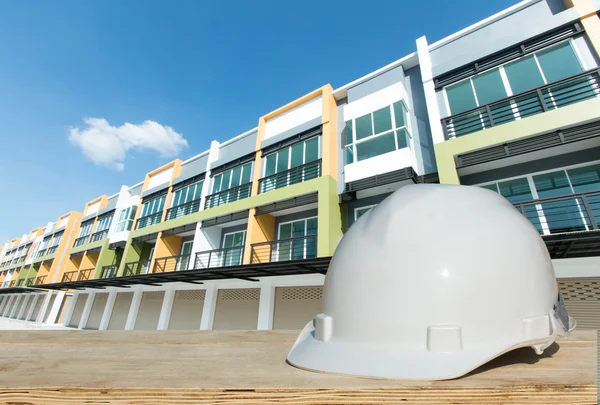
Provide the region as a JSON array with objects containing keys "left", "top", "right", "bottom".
[{"left": 250, "top": 235, "right": 317, "bottom": 263}]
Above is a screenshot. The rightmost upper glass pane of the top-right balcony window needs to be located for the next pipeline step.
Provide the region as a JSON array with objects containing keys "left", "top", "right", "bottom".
[{"left": 536, "top": 41, "right": 583, "bottom": 83}]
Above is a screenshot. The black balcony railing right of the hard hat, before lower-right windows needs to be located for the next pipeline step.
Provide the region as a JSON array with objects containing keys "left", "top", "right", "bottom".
[{"left": 514, "top": 191, "right": 600, "bottom": 235}]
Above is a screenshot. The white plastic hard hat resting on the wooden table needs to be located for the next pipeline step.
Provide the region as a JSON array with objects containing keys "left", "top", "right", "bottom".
[{"left": 288, "top": 184, "right": 575, "bottom": 380}]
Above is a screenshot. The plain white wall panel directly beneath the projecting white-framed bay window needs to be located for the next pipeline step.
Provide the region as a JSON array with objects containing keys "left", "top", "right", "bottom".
[{"left": 344, "top": 148, "right": 419, "bottom": 183}]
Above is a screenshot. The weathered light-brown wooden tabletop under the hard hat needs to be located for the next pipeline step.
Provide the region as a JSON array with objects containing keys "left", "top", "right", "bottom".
[{"left": 0, "top": 330, "right": 597, "bottom": 405}]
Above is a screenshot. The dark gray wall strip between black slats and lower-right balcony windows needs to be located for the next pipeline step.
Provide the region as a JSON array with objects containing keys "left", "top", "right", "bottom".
[{"left": 460, "top": 147, "right": 600, "bottom": 185}]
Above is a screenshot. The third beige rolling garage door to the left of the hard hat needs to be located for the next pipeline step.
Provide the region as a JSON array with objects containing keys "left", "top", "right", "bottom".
[{"left": 168, "top": 290, "right": 206, "bottom": 330}]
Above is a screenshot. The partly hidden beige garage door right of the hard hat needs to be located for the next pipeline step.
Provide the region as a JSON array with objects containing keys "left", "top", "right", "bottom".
[{"left": 558, "top": 277, "right": 600, "bottom": 329}]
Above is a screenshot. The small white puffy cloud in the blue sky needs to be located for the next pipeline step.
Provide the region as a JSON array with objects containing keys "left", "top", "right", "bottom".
[{"left": 69, "top": 118, "right": 189, "bottom": 171}]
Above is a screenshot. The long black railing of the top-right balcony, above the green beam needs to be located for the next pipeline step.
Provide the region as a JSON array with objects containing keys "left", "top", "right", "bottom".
[{"left": 442, "top": 69, "right": 600, "bottom": 140}]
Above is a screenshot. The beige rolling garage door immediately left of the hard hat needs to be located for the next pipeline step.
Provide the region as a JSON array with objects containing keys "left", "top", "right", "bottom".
[{"left": 273, "top": 286, "right": 323, "bottom": 330}]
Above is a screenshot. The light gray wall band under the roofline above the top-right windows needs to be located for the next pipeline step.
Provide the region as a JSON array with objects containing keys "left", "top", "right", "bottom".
[{"left": 431, "top": 0, "right": 579, "bottom": 76}]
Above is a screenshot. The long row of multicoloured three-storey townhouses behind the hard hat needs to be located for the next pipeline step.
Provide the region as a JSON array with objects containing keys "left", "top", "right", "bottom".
[{"left": 0, "top": 0, "right": 600, "bottom": 330}]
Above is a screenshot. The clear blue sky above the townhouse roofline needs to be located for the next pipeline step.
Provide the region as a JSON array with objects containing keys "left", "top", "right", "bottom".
[{"left": 0, "top": 0, "right": 516, "bottom": 243}]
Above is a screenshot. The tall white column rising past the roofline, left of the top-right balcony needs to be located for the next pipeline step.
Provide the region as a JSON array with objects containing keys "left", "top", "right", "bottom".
[{"left": 417, "top": 36, "right": 445, "bottom": 144}]
